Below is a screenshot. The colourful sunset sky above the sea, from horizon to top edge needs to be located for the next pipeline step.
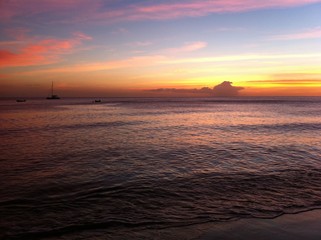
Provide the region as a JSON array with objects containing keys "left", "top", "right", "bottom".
[{"left": 0, "top": 0, "right": 321, "bottom": 97}]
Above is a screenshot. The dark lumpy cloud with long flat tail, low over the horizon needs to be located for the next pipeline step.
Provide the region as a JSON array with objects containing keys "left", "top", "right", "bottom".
[{"left": 146, "top": 81, "right": 244, "bottom": 97}]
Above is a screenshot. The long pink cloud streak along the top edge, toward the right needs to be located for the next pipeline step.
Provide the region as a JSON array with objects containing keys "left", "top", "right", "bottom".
[{"left": 96, "top": 0, "right": 321, "bottom": 21}]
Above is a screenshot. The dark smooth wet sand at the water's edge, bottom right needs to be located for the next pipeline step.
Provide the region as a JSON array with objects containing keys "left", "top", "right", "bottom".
[{"left": 39, "top": 210, "right": 321, "bottom": 240}]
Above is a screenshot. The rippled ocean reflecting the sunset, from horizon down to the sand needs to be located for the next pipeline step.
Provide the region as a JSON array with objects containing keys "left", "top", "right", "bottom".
[{"left": 0, "top": 97, "right": 321, "bottom": 239}]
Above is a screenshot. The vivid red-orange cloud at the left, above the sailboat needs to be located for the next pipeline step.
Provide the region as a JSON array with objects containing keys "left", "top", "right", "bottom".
[{"left": 0, "top": 32, "right": 91, "bottom": 68}]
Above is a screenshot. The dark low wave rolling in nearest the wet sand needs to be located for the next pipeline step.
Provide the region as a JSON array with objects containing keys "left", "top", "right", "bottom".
[{"left": 0, "top": 168, "right": 321, "bottom": 239}]
